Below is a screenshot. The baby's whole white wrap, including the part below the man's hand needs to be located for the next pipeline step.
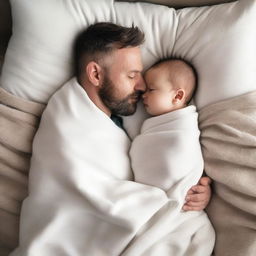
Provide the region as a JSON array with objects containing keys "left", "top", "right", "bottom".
[{"left": 128, "top": 106, "right": 215, "bottom": 256}]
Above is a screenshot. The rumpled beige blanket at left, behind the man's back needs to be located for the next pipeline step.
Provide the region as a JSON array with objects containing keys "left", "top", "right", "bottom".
[{"left": 0, "top": 88, "right": 44, "bottom": 256}]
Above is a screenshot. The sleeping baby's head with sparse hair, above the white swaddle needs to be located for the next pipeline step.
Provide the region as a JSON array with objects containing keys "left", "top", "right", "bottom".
[{"left": 143, "top": 59, "right": 197, "bottom": 116}]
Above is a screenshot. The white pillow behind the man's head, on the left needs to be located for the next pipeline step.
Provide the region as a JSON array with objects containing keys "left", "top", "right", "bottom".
[{"left": 1, "top": 0, "right": 115, "bottom": 103}]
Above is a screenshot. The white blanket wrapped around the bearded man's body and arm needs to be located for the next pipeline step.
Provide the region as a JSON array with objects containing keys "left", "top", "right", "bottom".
[{"left": 11, "top": 79, "right": 172, "bottom": 256}]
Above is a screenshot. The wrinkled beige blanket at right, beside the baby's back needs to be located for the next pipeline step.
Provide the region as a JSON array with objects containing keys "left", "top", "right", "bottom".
[{"left": 199, "top": 92, "right": 256, "bottom": 256}]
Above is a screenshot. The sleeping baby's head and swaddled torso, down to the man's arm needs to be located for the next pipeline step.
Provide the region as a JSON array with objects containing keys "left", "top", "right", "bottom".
[{"left": 131, "top": 59, "right": 200, "bottom": 190}]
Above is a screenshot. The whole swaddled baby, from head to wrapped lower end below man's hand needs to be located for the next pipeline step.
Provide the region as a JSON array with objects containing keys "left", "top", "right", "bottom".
[{"left": 130, "top": 59, "right": 215, "bottom": 256}]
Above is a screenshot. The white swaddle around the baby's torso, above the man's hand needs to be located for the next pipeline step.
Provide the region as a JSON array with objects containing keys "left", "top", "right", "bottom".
[{"left": 130, "top": 105, "right": 204, "bottom": 191}]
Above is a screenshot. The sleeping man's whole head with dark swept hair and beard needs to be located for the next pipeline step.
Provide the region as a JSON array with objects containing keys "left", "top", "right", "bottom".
[{"left": 75, "top": 22, "right": 145, "bottom": 115}]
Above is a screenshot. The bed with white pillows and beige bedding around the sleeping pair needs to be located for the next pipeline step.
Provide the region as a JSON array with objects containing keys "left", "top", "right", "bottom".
[{"left": 0, "top": 0, "right": 256, "bottom": 256}]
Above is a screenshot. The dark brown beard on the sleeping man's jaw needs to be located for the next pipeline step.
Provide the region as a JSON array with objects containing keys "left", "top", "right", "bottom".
[{"left": 99, "top": 72, "right": 141, "bottom": 116}]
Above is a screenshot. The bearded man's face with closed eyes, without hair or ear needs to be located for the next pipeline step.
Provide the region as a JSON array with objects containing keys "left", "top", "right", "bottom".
[{"left": 99, "top": 47, "right": 145, "bottom": 116}]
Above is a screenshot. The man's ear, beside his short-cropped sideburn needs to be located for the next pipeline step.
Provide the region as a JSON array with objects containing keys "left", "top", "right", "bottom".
[{"left": 86, "top": 61, "right": 103, "bottom": 86}]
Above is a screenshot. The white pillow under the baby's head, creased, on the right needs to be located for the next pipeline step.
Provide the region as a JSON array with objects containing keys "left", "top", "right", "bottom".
[{"left": 116, "top": 0, "right": 256, "bottom": 138}]
